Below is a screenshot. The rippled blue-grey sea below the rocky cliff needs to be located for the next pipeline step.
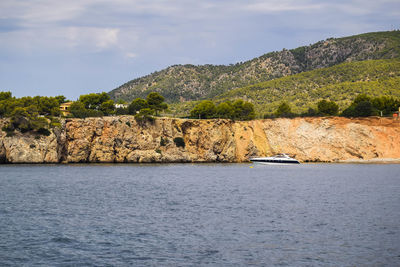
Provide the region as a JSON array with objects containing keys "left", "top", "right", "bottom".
[{"left": 0, "top": 164, "right": 400, "bottom": 266}]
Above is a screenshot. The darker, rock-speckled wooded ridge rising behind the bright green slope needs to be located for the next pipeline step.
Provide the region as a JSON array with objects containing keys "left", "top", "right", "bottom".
[{"left": 109, "top": 31, "right": 400, "bottom": 103}]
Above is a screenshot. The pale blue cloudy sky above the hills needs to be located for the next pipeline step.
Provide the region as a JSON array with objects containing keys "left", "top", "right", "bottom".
[{"left": 0, "top": 0, "right": 400, "bottom": 100}]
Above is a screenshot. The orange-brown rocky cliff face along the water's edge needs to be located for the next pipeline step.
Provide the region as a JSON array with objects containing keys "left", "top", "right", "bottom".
[{"left": 0, "top": 116, "right": 400, "bottom": 163}]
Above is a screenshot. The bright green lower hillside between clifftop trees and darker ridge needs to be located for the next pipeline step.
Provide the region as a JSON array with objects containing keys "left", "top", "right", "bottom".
[{"left": 171, "top": 59, "right": 400, "bottom": 116}]
